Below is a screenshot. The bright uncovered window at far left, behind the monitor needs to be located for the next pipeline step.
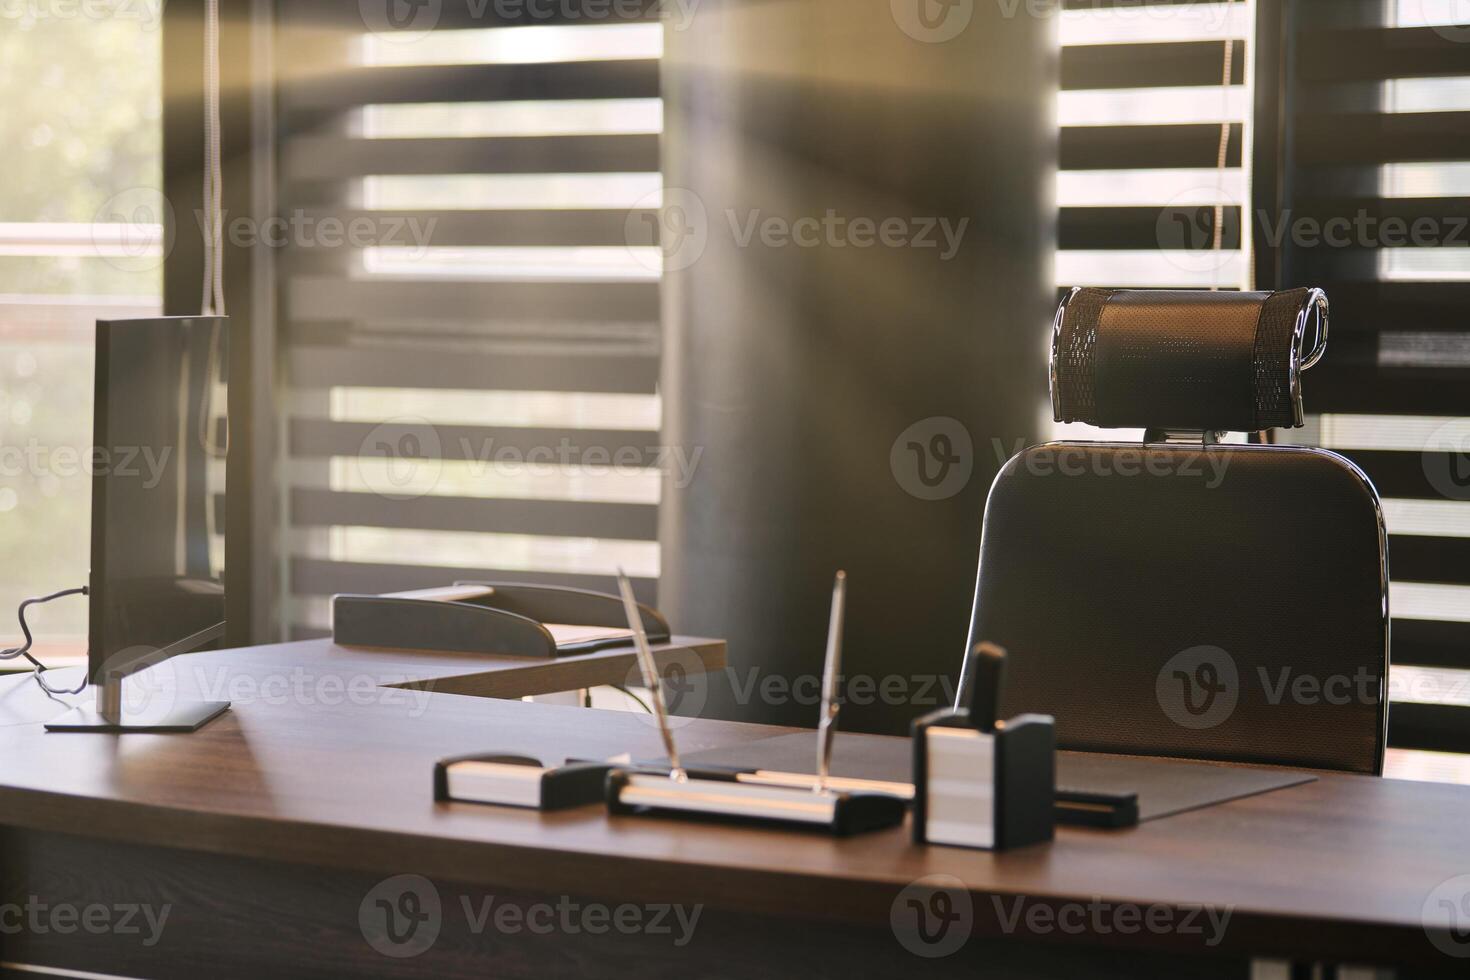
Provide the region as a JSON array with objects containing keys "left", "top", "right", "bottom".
[{"left": 0, "top": 0, "right": 163, "bottom": 663}]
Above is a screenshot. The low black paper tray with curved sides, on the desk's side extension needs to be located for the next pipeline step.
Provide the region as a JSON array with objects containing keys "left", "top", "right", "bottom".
[{"left": 332, "top": 582, "right": 670, "bottom": 658}]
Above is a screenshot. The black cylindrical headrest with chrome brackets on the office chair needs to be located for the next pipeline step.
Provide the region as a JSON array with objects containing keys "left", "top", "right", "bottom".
[{"left": 1051, "top": 288, "right": 1327, "bottom": 432}]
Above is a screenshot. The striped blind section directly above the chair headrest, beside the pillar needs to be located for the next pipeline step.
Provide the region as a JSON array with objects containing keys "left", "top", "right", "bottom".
[{"left": 1057, "top": 0, "right": 1251, "bottom": 288}]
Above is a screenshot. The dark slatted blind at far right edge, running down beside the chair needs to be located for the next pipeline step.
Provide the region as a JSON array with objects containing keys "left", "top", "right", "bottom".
[{"left": 1257, "top": 0, "right": 1470, "bottom": 751}]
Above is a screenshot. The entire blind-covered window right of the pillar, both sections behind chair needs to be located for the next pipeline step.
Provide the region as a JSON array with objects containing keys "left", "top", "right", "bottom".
[{"left": 1057, "top": 0, "right": 1470, "bottom": 774}]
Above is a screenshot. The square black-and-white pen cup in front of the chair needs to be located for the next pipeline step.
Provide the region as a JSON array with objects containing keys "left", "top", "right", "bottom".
[{"left": 913, "top": 710, "right": 1057, "bottom": 851}]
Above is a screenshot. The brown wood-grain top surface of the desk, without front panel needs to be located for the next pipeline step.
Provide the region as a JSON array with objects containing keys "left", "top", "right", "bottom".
[{"left": 0, "top": 645, "right": 1470, "bottom": 965}]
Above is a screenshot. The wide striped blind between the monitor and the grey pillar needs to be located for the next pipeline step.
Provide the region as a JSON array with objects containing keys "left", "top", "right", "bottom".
[{"left": 278, "top": 0, "right": 664, "bottom": 636}]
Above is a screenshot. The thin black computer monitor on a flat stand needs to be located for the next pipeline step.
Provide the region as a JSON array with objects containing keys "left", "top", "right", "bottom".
[{"left": 47, "top": 316, "right": 229, "bottom": 732}]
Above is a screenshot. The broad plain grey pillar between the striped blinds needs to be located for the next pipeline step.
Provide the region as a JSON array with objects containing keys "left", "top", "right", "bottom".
[{"left": 660, "top": 0, "right": 1055, "bottom": 732}]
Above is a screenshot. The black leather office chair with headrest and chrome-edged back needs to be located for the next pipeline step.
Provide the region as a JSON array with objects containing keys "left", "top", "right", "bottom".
[{"left": 961, "top": 289, "right": 1389, "bottom": 773}]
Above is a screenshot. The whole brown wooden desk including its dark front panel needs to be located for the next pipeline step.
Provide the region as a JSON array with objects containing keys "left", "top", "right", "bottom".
[{"left": 0, "top": 645, "right": 1470, "bottom": 980}]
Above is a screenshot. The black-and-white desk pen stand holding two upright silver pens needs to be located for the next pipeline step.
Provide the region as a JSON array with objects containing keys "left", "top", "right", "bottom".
[{"left": 607, "top": 572, "right": 907, "bottom": 836}]
